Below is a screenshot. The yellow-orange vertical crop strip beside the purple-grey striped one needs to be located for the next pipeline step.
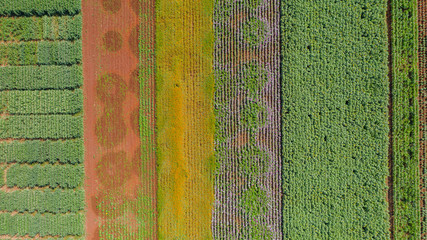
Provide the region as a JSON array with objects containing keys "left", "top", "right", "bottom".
[{"left": 156, "top": 0, "right": 214, "bottom": 239}]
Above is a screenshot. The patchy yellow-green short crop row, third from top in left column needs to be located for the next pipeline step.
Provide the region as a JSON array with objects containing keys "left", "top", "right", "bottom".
[{"left": 0, "top": 40, "right": 82, "bottom": 66}]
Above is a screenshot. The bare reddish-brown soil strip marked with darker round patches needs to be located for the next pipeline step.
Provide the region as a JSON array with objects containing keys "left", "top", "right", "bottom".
[{"left": 82, "top": 0, "right": 155, "bottom": 239}]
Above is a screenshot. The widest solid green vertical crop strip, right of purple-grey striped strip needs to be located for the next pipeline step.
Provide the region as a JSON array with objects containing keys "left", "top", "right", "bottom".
[{"left": 281, "top": 0, "right": 390, "bottom": 239}]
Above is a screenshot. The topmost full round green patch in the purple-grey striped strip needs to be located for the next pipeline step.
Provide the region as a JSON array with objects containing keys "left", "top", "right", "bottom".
[{"left": 241, "top": 17, "right": 268, "bottom": 47}]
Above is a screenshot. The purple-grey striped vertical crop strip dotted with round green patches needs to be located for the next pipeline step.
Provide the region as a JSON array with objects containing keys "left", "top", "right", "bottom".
[{"left": 212, "top": 0, "right": 283, "bottom": 239}]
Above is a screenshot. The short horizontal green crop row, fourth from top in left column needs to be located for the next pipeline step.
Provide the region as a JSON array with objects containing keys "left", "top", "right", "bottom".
[{"left": 0, "top": 65, "right": 83, "bottom": 90}]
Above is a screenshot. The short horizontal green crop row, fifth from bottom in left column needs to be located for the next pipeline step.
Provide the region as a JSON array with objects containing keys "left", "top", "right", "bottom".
[{"left": 0, "top": 115, "right": 83, "bottom": 139}]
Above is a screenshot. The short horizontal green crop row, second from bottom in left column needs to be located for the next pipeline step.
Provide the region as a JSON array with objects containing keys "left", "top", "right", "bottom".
[{"left": 0, "top": 189, "right": 85, "bottom": 213}]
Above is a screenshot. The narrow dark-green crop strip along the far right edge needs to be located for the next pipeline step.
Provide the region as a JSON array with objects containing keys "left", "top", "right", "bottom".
[{"left": 391, "top": 0, "right": 421, "bottom": 239}]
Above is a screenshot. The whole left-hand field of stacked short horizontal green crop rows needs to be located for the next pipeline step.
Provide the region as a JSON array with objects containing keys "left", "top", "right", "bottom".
[{"left": 0, "top": 1, "right": 85, "bottom": 239}]
